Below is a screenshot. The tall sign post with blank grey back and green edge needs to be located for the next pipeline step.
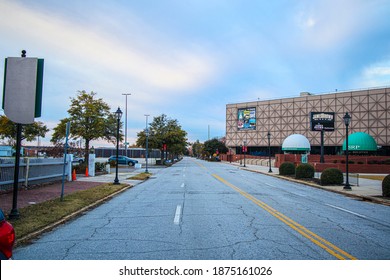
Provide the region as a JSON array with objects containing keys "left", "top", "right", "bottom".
[{"left": 3, "top": 50, "right": 44, "bottom": 219}]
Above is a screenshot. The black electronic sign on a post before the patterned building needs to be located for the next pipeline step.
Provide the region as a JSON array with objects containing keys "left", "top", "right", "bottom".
[{"left": 310, "top": 112, "right": 334, "bottom": 163}]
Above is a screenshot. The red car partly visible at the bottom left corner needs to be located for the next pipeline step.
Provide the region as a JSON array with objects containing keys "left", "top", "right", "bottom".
[{"left": 0, "top": 209, "right": 15, "bottom": 260}]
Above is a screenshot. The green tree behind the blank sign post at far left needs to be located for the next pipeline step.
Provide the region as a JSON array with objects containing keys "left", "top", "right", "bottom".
[{"left": 0, "top": 116, "right": 49, "bottom": 146}]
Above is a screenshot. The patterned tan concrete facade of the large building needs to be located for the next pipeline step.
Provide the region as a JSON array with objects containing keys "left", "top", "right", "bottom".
[{"left": 226, "top": 87, "right": 390, "bottom": 152}]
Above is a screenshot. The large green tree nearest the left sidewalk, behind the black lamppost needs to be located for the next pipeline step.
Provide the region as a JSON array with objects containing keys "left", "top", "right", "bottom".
[{"left": 51, "top": 90, "right": 122, "bottom": 163}]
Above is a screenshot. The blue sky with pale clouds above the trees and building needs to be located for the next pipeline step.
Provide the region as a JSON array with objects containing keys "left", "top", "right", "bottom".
[{"left": 0, "top": 0, "right": 390, "bottom": 147}]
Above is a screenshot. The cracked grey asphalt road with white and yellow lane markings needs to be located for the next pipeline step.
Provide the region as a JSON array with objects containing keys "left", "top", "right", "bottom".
[{"left": 14, "top": 158, "right": 390, "bottom": 260}]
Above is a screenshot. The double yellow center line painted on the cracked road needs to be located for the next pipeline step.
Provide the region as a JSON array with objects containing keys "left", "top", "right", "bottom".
[{"left": 212, "top": 174, "right": 357, "bottom": 260}]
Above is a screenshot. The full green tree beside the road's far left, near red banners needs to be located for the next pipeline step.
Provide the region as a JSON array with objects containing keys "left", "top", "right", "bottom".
[{"left": 136, "top": 114, "right": 187, "bottom": 160}]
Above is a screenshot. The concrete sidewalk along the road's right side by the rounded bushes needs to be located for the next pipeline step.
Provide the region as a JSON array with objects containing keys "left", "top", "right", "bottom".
[{"left": 224, "top": 162, "right": 390, "bottom": 206}]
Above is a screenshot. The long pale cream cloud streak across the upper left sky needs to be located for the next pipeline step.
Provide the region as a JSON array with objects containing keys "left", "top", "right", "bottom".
[{"left": 0, "top": 2, "right": 216, "bottom": 94}]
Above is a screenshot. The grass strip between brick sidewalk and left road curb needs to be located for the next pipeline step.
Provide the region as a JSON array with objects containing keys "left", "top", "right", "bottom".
[{"left": 10, "top": 184, "right": 128, "bottom": 243}]
